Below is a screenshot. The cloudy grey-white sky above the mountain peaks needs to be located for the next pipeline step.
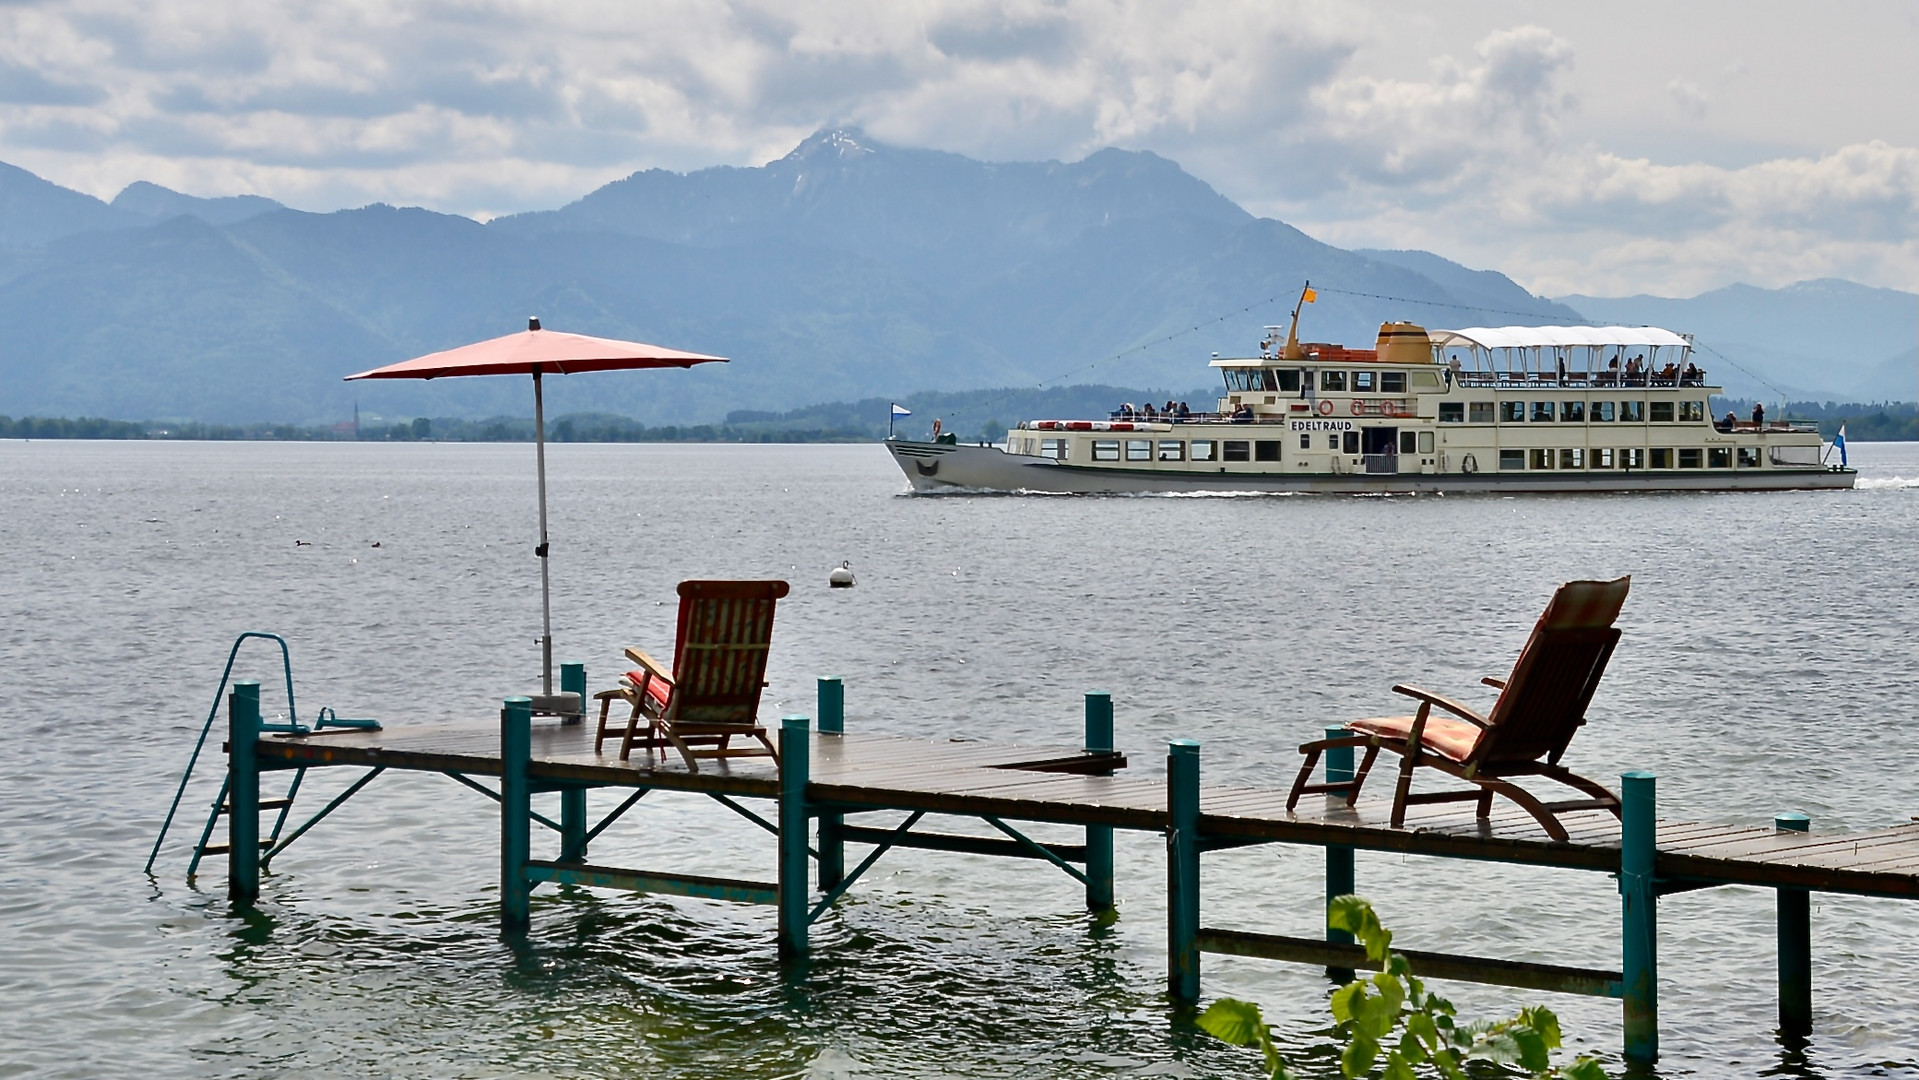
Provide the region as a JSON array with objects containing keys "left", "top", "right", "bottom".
[{"left": 0, "top": 0, "right": 1919, "bottom": 295}]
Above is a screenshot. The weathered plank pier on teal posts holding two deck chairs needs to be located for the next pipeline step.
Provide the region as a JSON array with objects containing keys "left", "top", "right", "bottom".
[{"left": 205, "top": 679, "right": 1919, "bottom": 1063}]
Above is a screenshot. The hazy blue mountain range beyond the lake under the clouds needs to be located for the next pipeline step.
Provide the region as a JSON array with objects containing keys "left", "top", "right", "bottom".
[{"left": 0, "top": 129, "right": 1919, "bottom": 424}]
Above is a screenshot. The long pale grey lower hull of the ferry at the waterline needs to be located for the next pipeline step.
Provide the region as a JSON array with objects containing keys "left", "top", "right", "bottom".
[{"left": 885, "top": 439, "right": 1858, "bottom": 495}]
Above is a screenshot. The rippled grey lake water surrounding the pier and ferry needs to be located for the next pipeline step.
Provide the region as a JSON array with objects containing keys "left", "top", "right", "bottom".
[{"left": 0, "top": 441, "right": 1919, "bottom": 1080}]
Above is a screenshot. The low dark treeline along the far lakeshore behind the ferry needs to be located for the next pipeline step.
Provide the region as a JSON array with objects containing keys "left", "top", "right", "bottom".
[{"left": 0, "top": 386, "right": 1919, "bottom": 443}]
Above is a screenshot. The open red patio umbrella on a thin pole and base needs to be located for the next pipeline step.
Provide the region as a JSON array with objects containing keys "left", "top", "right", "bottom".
[{"left": 347, "top": 318, "right": 725, "bottom": 712}]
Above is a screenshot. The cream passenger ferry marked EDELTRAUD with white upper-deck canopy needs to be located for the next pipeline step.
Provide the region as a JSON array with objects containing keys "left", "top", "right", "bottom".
[{"left": 887, "top": 285, "right": 1856, "bottom": 495}]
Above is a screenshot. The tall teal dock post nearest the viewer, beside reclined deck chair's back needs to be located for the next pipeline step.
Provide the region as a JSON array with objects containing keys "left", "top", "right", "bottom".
[{"left": 1620, "top": 771, "right": 1660, "bottom": 1065}]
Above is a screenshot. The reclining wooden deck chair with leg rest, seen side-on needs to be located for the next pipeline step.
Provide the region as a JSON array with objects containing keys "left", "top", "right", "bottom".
[{"left": 1286, "top": 577, "right": 1631, "bottom": 842}]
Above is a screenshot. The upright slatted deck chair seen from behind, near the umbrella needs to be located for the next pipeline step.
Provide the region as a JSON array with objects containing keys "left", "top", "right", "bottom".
[{"left": 593, "top": 581, "right": 789, "bottom": 773}]
